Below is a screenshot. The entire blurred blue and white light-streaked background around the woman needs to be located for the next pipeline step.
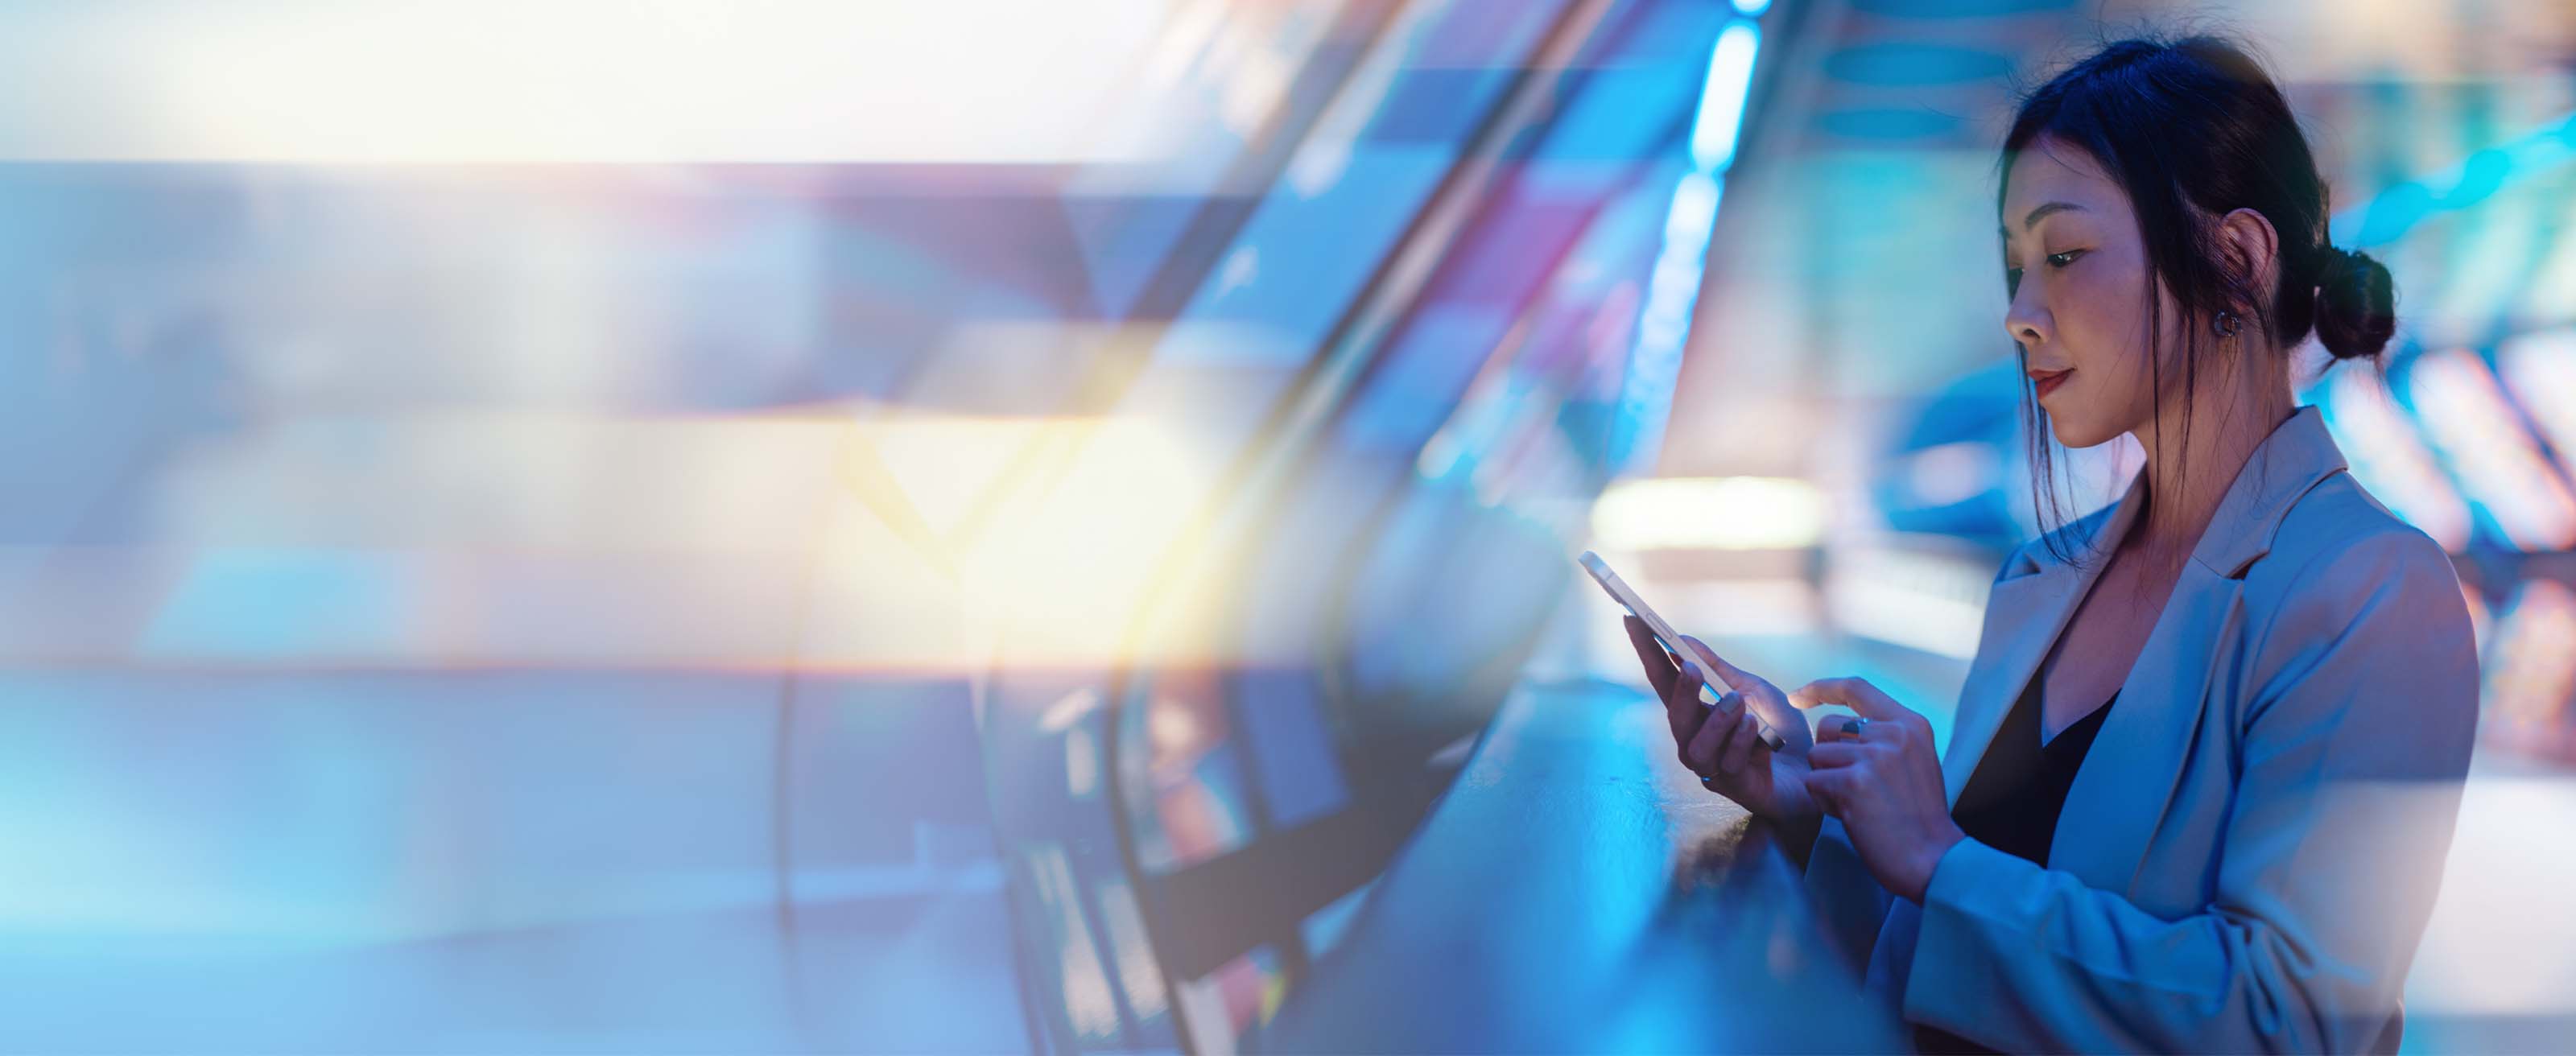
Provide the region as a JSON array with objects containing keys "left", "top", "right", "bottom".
[{"left": 0, "top": 0, "right": 2576, "bottom": 1054}]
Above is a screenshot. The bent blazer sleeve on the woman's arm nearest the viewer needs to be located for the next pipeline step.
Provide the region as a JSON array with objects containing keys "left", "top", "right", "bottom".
[{"left": 1906, "top": 530, "right": 2478, "bottom": 1054}]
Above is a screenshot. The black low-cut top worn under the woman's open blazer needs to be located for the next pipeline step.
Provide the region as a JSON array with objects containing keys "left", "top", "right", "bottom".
[{"left": 1914, "top": 674, "right": 2120, "bottom": 1054}]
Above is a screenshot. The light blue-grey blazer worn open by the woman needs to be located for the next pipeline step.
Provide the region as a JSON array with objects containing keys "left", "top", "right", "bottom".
[{"left": 1806, "top": 407, "right": 2478, "bottom": 1054}]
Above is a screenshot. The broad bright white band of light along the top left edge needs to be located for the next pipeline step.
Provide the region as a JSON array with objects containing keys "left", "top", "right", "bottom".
[{"left": 0, "top": 0, "right": 1169, "bottom": 163}]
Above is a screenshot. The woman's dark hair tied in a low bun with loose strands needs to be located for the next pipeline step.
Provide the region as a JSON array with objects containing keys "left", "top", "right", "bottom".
[{"left": 1996, "top": 36, "right": 2396, "bottom": 559}]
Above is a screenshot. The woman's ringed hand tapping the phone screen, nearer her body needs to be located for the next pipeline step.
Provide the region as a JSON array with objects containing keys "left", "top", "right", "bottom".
[{"left": 1788, "top": 678, "right": 1968, "bottom": 901}]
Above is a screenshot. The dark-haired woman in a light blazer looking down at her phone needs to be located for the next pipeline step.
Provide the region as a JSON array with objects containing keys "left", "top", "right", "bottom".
[{"left": 1631, "top": 36, "right": 2478, "bottom": 1054}]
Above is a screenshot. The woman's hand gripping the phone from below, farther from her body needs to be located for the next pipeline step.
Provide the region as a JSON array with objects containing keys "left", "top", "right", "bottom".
[{"left": 1625, "top": 616, "right": 1824, "bottom": 827}]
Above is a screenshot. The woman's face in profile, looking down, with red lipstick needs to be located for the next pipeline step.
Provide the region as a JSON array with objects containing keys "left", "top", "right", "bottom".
[{"left": 2001, "top": 139, "right": 2177, "bottom": 448}]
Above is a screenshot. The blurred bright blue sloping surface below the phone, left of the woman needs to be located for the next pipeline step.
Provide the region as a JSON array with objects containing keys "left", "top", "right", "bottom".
[{"left": 1249, "top": 683, "right": 1904, "bottom": 1054}]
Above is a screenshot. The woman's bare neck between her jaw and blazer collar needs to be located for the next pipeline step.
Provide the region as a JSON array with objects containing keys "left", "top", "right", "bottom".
[{"left": 2125, "top": 371, "right": 2297, "bottom": 562}]
